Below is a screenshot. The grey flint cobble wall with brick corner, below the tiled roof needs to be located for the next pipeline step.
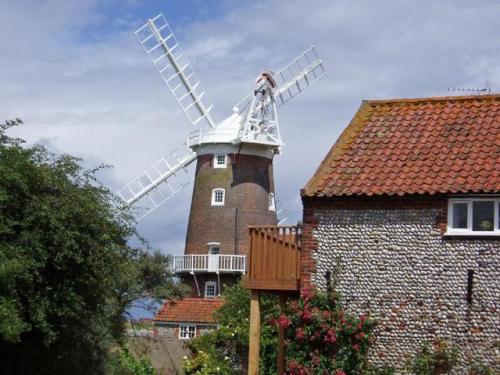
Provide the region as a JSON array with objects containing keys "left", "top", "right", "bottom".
[{"left": 302, "top": 198, "right": 500, "bottom": 374}]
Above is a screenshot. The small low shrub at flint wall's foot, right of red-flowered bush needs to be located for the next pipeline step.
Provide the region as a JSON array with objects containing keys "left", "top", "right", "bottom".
[{"left": 407, "top": 339, "right": 460, "bottom": 375}]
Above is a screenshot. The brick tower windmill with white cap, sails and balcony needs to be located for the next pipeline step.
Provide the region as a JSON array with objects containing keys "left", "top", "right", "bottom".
[{"left": 118, "top": 14, "right": 325, "bottom": 298}]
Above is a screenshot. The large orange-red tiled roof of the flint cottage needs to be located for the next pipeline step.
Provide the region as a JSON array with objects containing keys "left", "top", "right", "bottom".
[{"left": 303, "top": 94, "right": 500, "bottom": 197}]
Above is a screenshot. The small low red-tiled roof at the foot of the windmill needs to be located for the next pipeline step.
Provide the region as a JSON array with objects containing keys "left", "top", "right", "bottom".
[{"left": 155, "top": 298, "right": 224, "bottom": 323}]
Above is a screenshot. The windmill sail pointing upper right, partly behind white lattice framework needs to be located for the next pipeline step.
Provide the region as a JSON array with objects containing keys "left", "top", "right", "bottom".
[{"left": 235, "top": 46, "right": 326, "bottom": 113}]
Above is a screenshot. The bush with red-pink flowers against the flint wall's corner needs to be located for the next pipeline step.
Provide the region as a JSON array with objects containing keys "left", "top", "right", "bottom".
[{"left": 280, "top": 288, "right": 375, "bottom": 375}]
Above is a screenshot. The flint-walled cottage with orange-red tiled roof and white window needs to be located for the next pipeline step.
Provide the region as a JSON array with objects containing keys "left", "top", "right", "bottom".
[{"left": 301, "top": 95, "right": 500, "bottom": 374}]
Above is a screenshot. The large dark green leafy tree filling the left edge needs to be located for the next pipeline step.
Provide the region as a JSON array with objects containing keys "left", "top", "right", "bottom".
[{"left": 0, "top": 120, "right": 183, "bottom": 375}]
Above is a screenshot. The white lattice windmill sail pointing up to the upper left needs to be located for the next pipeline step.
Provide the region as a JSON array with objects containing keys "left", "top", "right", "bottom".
[{"left": 135, "top": 13, "right": 215, "bottom": 128}]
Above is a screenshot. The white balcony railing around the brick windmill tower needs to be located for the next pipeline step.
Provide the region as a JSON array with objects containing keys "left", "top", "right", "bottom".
[{"left": 172, "top": 254, "right": 246, "bottom": 273}]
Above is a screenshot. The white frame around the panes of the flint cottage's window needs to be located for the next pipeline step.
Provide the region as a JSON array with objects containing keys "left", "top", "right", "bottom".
[{"left": 446, "top": 197, "right": 500, "bottom": 236}]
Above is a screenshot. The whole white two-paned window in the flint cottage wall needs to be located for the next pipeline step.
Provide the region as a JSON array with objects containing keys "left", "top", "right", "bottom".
[{"left": 447, "top": 198, "right": 500, "bottom": 236}]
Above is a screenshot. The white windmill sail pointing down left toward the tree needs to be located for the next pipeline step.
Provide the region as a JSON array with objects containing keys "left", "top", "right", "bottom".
[{"left": 117, "top": 149, "right": 196, "bottom": 220}]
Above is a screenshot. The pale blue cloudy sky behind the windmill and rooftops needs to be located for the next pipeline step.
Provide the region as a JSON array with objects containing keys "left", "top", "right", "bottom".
[{"left": 0, "top": 0, "right": 500, "bottom": 254}]
